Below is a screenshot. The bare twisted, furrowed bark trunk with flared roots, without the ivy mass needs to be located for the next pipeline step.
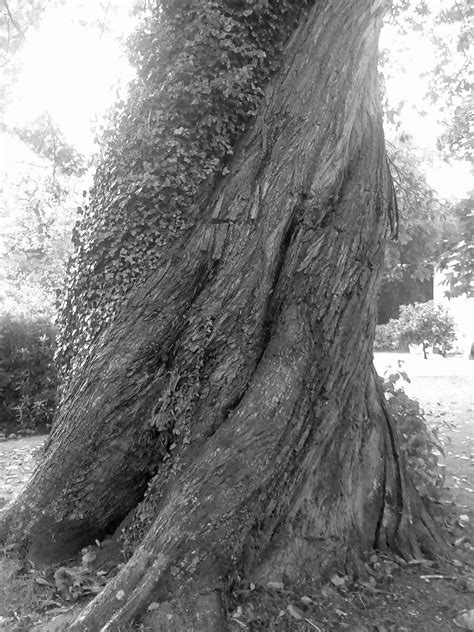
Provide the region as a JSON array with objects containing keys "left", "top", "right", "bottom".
[{"left": 1, "top": 0, "right": 437, "bottom": 632}]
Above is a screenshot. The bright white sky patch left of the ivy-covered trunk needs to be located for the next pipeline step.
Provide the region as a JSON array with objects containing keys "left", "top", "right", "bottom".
[{"left": 6, "top": 3, "right": 133, "bottom": 153}]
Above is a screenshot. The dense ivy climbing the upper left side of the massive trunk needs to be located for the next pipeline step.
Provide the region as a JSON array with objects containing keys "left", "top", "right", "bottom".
[{"left": 59, "top": 0, "right": 311, "bottom": 380}]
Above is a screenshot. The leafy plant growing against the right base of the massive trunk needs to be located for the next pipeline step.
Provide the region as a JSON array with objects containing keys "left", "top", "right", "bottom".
[{"left": 383, "top": 367, "right": 444, "bottom": 501}]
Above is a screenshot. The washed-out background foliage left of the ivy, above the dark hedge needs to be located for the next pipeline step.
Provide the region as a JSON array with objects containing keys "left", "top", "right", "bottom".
[{"left": 0, "top": 137, "right": 82, "bottom": 298}]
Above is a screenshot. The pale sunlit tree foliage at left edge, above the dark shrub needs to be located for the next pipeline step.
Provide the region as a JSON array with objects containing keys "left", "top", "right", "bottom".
[{"left": 0, "top": 117, "right": 87, "bottom": 294}]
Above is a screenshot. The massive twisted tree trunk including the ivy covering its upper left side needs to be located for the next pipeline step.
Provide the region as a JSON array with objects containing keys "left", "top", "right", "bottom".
[{"left": 1, "top": 0, "right": 442, "bottom": 632}]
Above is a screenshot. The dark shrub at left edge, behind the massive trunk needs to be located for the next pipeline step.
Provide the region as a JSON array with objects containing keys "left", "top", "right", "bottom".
[{"left": 0, "top": 288, "right": 57, "bottom": 434}]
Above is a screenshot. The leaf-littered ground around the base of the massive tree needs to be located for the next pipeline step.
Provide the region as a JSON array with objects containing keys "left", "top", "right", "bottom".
[{"left": 0, "top": 353, "right": 474, "bottom": 632}]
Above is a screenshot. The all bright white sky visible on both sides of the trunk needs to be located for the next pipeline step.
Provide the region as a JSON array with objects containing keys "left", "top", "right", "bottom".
[{"left": 1, "top": 0, "right": 472, "bottom": 198}]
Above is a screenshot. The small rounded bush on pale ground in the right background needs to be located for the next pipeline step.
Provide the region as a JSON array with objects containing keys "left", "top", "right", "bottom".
[{"left": 399, "top": 301, "right": 456, "bottom": 358}]
